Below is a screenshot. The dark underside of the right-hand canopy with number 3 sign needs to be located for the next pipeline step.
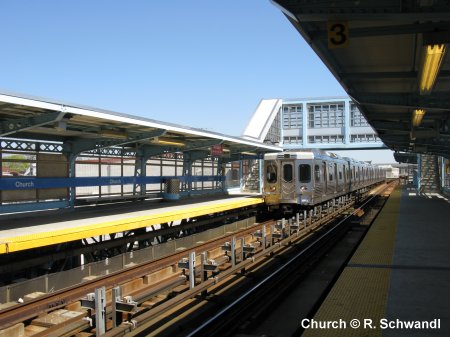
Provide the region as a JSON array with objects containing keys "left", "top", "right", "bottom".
[{"left": 273, "top": 0, "right": 450, "bottom": 158}]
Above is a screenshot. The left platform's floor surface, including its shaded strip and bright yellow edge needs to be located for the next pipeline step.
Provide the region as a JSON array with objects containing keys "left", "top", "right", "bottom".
[{"left": 0, "top": 196, "right": 263, "bottom": 254}]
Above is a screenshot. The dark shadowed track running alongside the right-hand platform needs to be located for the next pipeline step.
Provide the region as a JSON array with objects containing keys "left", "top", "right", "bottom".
[{"left": 187, "top": 181, "right": 393, "bottom": 337}]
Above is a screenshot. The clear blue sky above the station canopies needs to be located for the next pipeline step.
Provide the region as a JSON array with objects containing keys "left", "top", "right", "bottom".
[{"left": 0, "top": 0, "right": 345, "bottom": 136}]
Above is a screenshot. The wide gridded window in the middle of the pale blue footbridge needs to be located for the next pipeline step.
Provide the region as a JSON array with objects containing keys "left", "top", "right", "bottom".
[{"left": 308, "top": 103, "right": 344, "bottom": 129}]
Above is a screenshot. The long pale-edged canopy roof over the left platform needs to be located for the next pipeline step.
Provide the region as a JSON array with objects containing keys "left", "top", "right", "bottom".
[{"left": 0, "top": 92, "right": 282, "bottom": 159}]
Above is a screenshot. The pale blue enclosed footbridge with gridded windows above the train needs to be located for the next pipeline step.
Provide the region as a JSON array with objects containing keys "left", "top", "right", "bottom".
[{"left": 243, "top": 97, "right": 386, "bottom": 150}]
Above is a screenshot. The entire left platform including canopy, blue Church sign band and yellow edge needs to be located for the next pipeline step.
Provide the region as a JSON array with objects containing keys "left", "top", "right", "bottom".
[{"left": 0, "top": 92, "right": 274, "bottom": 262}]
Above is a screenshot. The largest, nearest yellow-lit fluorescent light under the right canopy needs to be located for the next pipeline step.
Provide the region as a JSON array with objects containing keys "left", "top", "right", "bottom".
[{"left": 420, "top": 44, "right": 446, "bottom": 95}]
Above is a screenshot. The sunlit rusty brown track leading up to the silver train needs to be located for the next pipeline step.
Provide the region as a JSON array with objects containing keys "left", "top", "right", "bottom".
[{"left": 0, "top": 182, "right": 394, "bottom": 336}]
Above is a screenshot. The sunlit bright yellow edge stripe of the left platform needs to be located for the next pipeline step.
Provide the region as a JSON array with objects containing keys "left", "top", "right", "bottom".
[{"left": 0, "top": 197, "right": 264, "bottom": 254}]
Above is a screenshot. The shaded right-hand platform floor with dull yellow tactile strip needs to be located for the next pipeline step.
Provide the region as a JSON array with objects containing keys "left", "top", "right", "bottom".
[{"left": 302, "top": 186, "right": 450, "bottom": 337}]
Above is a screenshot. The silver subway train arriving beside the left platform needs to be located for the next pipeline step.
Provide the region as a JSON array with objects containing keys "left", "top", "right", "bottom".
[{"left": 263, "top": 150, "right": 385, "bottom": 211}]
